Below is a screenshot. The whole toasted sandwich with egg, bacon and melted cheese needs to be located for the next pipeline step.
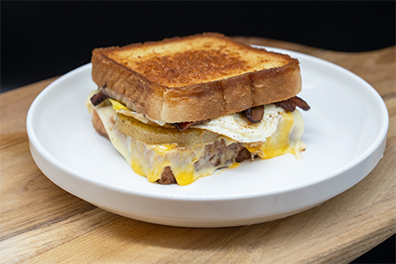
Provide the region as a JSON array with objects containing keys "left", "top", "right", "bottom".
[{"left": 86, "top": 33, "right": 310, "bottom": 185}]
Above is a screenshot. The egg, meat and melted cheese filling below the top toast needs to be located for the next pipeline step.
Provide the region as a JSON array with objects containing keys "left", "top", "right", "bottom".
[{"left": 86, "top": 95, "right": 305, "bottom": 185}]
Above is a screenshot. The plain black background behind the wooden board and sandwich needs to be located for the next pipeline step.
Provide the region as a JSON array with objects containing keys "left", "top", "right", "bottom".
[{"left": 1, "top": 1, "right": 395, "bottom": 263}]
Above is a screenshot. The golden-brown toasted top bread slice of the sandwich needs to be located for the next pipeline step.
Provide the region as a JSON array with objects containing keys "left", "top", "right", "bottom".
[{"left": 92, "top": 33, "right": 301, "bottom": 123}]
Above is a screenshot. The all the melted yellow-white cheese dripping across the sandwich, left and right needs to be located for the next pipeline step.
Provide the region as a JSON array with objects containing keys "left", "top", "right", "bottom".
[{"left": 91, "top": 97, "right": 305, "bottom": 185}]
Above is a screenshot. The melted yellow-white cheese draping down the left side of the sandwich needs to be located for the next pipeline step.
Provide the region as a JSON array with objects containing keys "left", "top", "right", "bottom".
[{"left": 95, "top": 102, "right": 223, "bottom": 185}]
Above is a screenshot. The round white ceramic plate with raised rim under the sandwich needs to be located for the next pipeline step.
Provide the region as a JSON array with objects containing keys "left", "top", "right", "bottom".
[{"left": 27, "top": 48, "right": 389, "bottom": 227}]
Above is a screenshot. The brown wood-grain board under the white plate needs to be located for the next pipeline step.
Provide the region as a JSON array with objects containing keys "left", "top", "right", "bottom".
[{"left": 0, "top": 37, "right": 396, "bottom": 263}]
